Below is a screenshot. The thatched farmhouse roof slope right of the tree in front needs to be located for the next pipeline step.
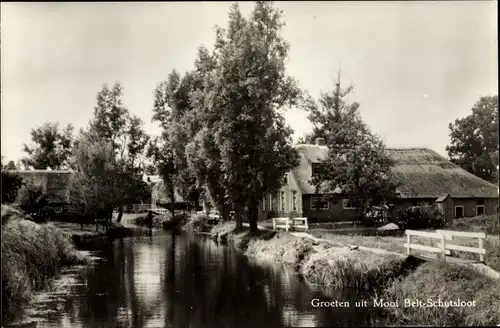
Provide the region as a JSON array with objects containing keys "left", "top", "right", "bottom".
[{"left": 387, "top": 148, "right": 498, "bottom": 198}]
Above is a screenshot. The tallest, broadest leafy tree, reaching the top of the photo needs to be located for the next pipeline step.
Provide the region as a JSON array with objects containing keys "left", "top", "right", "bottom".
[{"left": 186, "top": 1, "right": 300, "bottom": 231}]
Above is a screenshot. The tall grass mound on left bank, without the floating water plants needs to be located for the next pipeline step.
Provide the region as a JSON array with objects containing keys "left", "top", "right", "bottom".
[{"left": 1, "top": 205, "right": 86, "bottom": 321}]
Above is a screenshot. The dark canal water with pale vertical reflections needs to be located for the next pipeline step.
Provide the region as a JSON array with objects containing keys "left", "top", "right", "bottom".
[{"left": 8, "top": 231, "right": 386, "bottom": 328}]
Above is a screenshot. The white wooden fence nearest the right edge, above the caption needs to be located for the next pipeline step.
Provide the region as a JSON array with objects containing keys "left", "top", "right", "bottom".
[{"left": 404, "top": 230, "right": 486, "bottom": 262}]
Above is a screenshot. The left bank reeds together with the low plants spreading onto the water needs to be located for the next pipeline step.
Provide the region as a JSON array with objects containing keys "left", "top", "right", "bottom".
[{"left": 1, "top": 205, "right": 132, "bottom": 323}]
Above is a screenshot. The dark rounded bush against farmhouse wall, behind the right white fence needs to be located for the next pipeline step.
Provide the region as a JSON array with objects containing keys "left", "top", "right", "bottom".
[{"left": 399, "top": 203, "right": 445, "bottom": 229}]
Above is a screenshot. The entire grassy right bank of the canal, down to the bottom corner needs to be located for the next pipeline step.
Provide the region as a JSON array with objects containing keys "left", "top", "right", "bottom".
[{"left": 182, "top": 214, "right": 500, "bottom": 326}]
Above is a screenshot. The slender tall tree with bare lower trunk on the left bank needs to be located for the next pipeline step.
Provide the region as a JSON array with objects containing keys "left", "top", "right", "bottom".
[{"left": 89, "top": 83, "right": 149, "bottom": 222}]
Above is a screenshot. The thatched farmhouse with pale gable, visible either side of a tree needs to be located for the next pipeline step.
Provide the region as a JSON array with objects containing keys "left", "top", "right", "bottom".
[{"left": 259, "top": 138, "right": 499, "bottom": 222}]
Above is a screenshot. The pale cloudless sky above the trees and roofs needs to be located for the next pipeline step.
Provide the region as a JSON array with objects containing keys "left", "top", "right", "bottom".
[{"left": 1, "top": 1, "right": 498, "bottom": 161}]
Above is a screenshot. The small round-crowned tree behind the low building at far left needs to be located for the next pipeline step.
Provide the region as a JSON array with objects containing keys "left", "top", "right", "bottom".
[{"left": 21, "top": 122, "right": 73, "bottom": 170}]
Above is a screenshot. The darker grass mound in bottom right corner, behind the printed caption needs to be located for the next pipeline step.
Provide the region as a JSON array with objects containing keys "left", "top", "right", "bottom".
[{"left": 381, "top": 262, "right": 500, "bottom": 327}]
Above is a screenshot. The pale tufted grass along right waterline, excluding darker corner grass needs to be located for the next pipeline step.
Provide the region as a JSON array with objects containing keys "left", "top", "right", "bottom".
[{"left": 211, "top": 223, "right": 411, "bottom": 292}]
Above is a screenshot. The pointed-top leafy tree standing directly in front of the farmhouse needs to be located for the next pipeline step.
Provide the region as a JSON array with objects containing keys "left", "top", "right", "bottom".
[{"left": 306, "top": 73, "right": 396, "bottom": 216}]
